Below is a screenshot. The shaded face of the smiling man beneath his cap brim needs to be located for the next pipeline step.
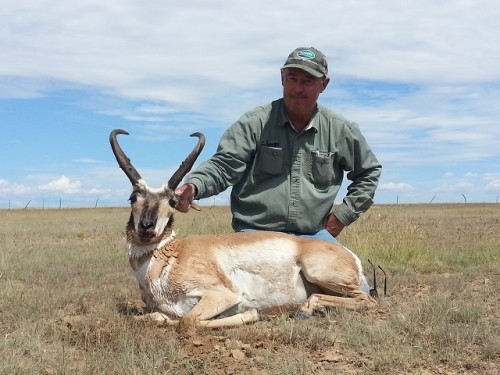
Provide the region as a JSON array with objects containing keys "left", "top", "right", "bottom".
[{"left": 281, "top": 68, "right": 330, "bottom": 116}]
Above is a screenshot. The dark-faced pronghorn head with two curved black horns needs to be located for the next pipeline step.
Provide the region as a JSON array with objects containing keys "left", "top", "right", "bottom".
[{"left": 109, "top": 129, "right": 205, "bottom": 246}]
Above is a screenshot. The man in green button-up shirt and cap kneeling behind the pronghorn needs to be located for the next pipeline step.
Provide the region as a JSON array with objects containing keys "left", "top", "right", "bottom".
[{"left": 175, "top": 47, "right": 382, "bottom": 241}]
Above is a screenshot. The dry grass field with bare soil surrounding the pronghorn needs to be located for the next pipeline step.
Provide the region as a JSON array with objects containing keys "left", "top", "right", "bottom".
[{"left": 0, "top": 204, "right": 500, "bottom": 375}]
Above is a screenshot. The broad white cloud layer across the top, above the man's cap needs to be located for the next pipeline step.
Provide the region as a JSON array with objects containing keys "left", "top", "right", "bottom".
[{"left": 0, "top": 0, "right": 500, "bottom": 100}]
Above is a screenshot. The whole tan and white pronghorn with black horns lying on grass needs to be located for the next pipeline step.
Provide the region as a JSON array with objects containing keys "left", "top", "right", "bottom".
[{"left": 109, "top": 129, "right": 377, "bottom": 328}]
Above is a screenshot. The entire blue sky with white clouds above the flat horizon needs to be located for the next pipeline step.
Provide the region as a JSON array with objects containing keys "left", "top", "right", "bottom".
[{"left": 0, "top": 0, "right": 500, "bottom": 208}]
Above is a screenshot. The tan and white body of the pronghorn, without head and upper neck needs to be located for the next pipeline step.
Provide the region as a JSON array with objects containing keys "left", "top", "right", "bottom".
[{"left": 130, "top": 232, "right": 377, "bottom": 328}]
